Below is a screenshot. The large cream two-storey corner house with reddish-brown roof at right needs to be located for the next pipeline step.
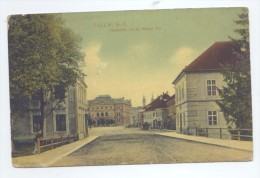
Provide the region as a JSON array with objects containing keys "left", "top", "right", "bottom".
[{"left": 173, "top": 41, "right": 234, "bottom": 137}]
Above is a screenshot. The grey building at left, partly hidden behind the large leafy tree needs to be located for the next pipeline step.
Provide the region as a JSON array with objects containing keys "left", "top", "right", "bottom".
[{"left": 12, "top": 79, "right": 87, "bottom": 152}]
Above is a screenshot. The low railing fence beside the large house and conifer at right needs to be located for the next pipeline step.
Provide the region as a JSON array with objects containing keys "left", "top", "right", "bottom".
[{"left": 186, "top": 127, "right": 253, "bottom": 140}]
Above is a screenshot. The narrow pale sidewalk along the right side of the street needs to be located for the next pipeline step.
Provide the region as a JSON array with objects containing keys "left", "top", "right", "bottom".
[{"left": 156, "top": 131, "right": 253, "bottom": 151}]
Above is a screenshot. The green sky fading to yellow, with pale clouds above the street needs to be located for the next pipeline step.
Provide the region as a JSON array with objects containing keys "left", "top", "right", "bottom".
[{"left": 62, "top": 8, "right": 242, "bottom": 106}]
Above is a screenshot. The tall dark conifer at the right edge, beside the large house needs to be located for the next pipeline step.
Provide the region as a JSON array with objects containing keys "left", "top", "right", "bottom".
[{"left": 217, "top": 9, "right": 252, "bottom": 129}]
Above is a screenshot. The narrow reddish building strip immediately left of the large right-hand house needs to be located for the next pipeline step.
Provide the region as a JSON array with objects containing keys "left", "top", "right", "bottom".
[{"left": 166, "top": 95, "right": 176, "bottom": 130}]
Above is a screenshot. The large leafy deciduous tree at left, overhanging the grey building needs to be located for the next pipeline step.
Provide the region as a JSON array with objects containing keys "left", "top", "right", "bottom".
[{"left": 8, "top": 14, "right": 84, "bottom": 134}]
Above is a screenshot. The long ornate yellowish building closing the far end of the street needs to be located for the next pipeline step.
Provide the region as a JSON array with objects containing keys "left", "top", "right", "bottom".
[{"left": 88, "top": 95, "right": 131, "bottom": 126}]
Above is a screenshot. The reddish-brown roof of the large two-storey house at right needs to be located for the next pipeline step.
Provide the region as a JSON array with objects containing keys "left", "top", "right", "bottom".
[{"left": 173, "top": 41, "right": 236, "bottom": 83}]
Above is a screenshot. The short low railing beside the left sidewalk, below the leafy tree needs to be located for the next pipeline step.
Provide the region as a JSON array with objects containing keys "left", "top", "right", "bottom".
[{"left": 36, "top": 135, "right": 79, "bottom": 154}]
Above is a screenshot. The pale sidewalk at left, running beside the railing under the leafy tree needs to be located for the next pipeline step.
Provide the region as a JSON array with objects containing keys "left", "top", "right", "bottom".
[{"left": 12, "top": 136, "right": 98, "bottom": 167}]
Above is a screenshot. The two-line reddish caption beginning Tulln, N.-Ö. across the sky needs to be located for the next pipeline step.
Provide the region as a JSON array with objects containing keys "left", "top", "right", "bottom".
[{"left": 93, "top": 22, "right": 162, "bottom": 32}]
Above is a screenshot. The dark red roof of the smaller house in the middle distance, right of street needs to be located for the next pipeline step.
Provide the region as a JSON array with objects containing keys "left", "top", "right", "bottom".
[{"left": 144, "top": 93, "right": 170, "bottom": 111}]
